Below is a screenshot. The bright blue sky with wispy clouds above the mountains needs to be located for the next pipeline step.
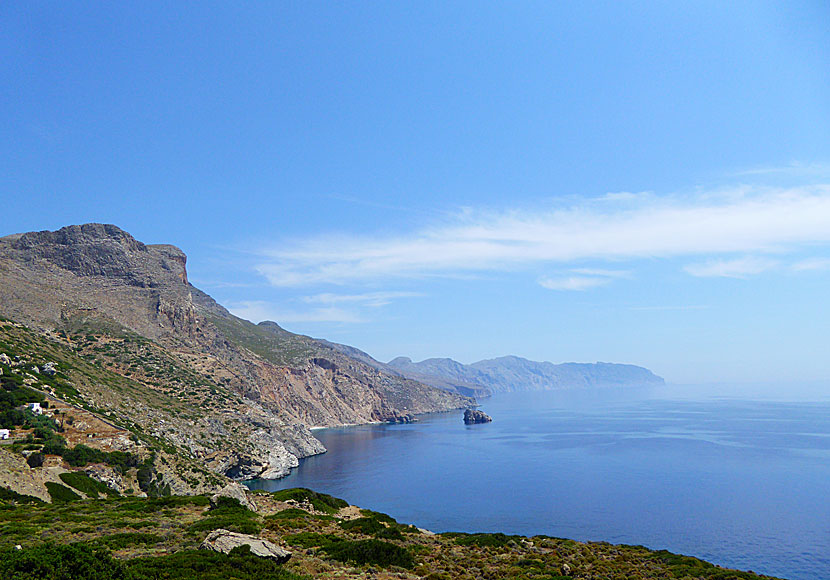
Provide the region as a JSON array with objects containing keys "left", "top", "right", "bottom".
[{"left": 0, "top": 2, "right": 830, "bottom": 382}]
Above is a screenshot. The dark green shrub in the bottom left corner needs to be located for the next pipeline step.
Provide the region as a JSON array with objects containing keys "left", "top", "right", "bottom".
[{"left": 0, "top": 543, "right": 129, "bottom": 580}]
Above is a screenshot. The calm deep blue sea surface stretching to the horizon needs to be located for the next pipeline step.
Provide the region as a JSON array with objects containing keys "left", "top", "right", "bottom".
[{"left": 248, "top": 384, "right": 830, "bottom": 580}]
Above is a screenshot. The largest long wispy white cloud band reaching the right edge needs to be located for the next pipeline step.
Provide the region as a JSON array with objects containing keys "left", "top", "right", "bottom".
[{"left": 252, "top": 185, "right": 830, "bottom": 286}]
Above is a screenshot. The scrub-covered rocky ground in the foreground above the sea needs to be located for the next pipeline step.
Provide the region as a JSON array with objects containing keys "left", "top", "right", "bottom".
[{"left": 0, "top": 482, "right": 788, "bottom": 580}]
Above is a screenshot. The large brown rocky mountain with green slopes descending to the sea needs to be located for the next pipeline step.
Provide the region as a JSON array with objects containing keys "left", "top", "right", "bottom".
[{"left": 0, "top": 224, "right": 471, "bottom": 493}]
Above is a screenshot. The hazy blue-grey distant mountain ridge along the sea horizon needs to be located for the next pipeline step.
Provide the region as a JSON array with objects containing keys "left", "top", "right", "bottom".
[{"left": 387, "top": 356, "right": 665, "bottom": 392}]
